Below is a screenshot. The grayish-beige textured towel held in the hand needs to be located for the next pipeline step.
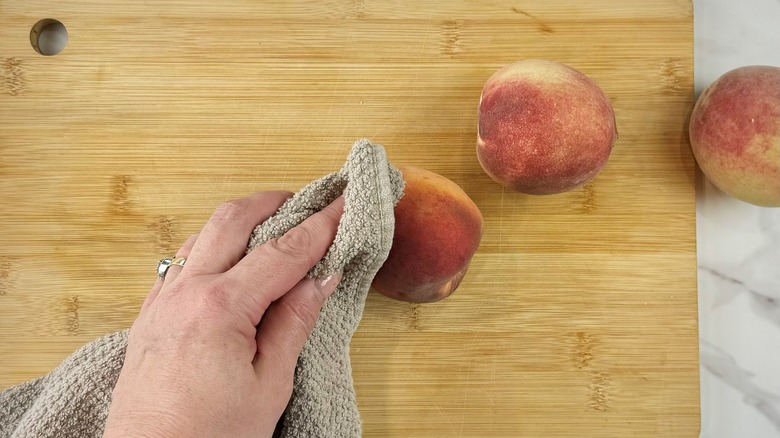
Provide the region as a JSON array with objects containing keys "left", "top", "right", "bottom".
[{"left": 0, "top": 140, "right": 404, "bottom": 438}]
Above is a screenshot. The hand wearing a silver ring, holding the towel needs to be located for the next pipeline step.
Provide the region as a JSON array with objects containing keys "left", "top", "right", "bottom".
[{"left": 104, "top": 192, "right": 344, "bottom": 437}]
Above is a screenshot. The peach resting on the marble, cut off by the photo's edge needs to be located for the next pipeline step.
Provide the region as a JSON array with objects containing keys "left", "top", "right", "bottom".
[{"left": 688, "top": 66, "right": 780, "bottom": 207}]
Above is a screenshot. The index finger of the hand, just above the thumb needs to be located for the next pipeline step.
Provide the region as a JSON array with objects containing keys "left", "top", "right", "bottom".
[{"left": 228, "top": 196, "right": 344, "bottom": 324}]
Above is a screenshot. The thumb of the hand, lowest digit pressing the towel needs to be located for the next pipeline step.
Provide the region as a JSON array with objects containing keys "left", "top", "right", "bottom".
[{"left": 254, "top": 273, "right": 341, "bottom": 387}]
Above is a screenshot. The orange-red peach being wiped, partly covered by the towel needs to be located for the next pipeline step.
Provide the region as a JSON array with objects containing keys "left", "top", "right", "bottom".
[{"left": 372, "top": 166, "right": 482, "bottom": 303}]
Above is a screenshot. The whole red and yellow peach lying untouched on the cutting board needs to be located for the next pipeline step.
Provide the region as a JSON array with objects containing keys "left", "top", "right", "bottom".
[{"left": 477, "top": 59, "right": 617, "bottom": 195}]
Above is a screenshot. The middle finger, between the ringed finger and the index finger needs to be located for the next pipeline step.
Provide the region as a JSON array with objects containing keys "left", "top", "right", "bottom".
[{"left": 187, "top": 191, "right": 292, "bottom": 274}]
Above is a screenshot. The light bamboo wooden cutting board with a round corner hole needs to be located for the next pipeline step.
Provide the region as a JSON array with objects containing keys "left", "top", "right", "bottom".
[{"left": 0, "top": 0, "right": 699, "bottom": 437}]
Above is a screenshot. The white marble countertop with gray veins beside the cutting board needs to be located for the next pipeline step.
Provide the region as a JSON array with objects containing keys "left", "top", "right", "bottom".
[{"left": 693, "top": 0, "right": 780, "bottom": 438}]
